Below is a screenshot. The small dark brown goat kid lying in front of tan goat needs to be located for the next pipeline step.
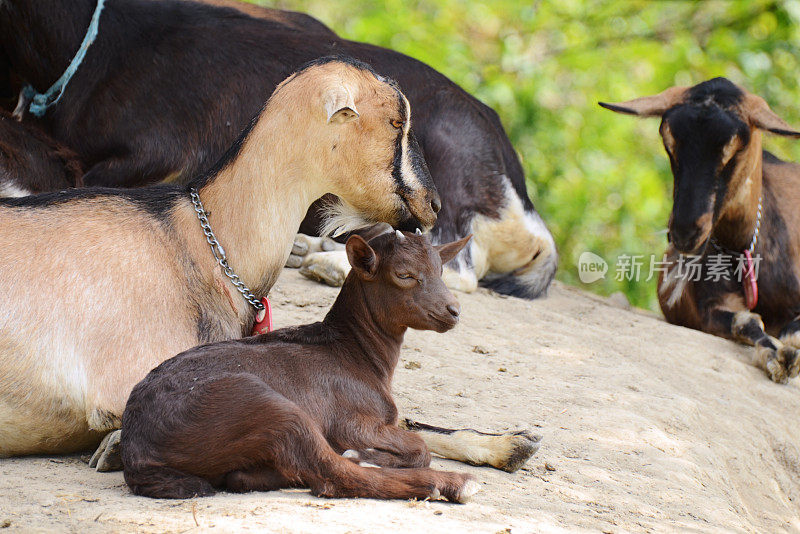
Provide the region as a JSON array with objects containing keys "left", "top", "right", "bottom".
[{"left": 122, "top": 230, "right": 480, "bottom": 502}]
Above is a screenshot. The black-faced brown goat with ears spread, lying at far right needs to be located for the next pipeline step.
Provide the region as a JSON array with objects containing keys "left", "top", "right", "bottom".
[{"left": 600, "top": 78, "right": 800, "bottom": 382}]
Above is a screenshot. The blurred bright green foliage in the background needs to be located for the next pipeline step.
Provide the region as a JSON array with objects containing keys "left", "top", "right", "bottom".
[{"left": 250, "top": 0, "right": 800, "bottom": 309}]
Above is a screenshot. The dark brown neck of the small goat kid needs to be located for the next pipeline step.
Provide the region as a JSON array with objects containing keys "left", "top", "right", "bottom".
[{"left": 324, "top": 273, "right": 407, "bottom": 381}]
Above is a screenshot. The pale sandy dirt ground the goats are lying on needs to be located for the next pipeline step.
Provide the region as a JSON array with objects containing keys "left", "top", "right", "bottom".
[{"left": 0, "top": 271, "right": 800, "bottom": 533}]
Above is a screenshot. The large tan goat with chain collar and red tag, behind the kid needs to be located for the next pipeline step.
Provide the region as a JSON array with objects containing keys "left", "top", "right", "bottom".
[{"left": 0, "top": 58, "right": 436, "bottom": 456}]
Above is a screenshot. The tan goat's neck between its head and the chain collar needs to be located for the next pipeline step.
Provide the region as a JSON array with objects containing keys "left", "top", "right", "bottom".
[{"left": 181, "top": 106, "right": 326, "bottom": 308}]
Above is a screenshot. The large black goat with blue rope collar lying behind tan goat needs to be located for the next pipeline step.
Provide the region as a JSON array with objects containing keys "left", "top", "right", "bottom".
[{"left": 0, "top": 0, "right": 557, "bottom": 298}]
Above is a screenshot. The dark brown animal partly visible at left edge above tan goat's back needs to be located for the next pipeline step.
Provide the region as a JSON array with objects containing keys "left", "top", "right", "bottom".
[{"left": 0, "top": 110, "right": 83, "bottom": 197}]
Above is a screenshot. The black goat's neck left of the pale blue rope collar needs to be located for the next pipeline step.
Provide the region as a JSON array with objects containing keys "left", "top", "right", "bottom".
[{"left": 0, "top": 0, "right": 97, "bottom": 91}]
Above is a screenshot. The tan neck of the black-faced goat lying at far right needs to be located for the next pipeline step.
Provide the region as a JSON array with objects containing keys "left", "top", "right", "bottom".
[{"left": 712, "top": 128, "right": 763, "bottom": 254}]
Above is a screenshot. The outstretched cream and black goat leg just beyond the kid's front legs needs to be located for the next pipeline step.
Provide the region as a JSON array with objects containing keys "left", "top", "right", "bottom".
[{"left": 401, "top": 419, "right": 542, "bottom": 473}]
